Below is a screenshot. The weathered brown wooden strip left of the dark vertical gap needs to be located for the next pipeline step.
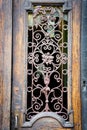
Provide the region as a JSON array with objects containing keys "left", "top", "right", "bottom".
[{"left": 0, "top": 0, "right": 12, "bottom": 130}]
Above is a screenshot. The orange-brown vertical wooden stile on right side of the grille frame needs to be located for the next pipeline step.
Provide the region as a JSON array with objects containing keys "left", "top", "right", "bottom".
[{"left": 72, "top": 0, "right": 82, "bottom": 130}]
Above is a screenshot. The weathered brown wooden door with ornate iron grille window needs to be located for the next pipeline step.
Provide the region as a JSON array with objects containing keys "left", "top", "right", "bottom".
[{"left": 11, "top": 0, "right": 81, "bottom": 130}]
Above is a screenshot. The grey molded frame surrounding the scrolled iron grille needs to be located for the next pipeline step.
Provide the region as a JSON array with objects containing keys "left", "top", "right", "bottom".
[{"left": 23, "top": 0, "right": 73, "bottom": 127}]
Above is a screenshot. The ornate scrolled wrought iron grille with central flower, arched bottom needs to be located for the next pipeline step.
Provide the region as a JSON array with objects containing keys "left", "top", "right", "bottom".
[{"left": 26, "top": 5, "right": 69, "bottom": 121}]
